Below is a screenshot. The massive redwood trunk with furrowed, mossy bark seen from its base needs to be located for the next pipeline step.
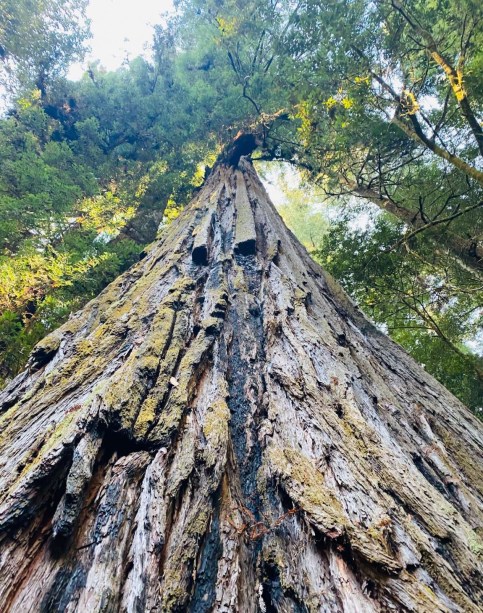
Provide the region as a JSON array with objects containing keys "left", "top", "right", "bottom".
[{"left": 0, "top": 159, "right": 483, "bottom": 613}]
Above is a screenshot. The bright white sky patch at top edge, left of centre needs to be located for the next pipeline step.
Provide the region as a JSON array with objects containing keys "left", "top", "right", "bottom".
[{"left": 68, "top": 0, "right": 173, "bottom": 80}]
